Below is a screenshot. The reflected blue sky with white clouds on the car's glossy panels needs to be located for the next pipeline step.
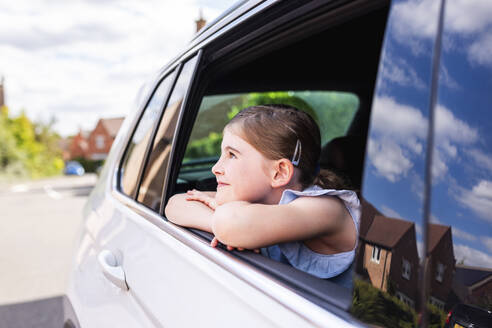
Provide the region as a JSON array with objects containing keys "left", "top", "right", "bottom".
[{"left": 364, "top": 0, "right": 492, "bottom": 268}]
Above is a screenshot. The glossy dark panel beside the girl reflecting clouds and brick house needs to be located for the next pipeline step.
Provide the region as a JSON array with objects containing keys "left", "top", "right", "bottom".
[{"left": 352, "top": 1, "right": 438, "bottom": 327}]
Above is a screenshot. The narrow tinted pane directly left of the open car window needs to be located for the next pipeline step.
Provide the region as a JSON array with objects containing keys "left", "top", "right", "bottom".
[{"left": 137, "top": 57, "right": 196, "bottom": 211}]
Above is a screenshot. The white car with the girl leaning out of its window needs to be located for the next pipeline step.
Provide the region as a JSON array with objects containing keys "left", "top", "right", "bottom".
[{"left": 65, "top": 0, "right": 492, "bottom": 327}]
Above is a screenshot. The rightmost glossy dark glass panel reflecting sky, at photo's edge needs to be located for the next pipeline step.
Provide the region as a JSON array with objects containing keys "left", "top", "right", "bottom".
[{"left": 427, "top": 1, "right": 492, "bottom": 313}]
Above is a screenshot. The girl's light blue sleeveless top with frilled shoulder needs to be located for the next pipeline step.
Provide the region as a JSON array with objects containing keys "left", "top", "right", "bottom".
[{"left": 261, "top": 186, "right": 361, "bottom": 288}]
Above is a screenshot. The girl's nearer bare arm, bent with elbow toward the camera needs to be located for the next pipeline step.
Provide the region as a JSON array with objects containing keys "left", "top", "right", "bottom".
[{"left": 212, "top": 196, "right": 347, "bottom": 248}]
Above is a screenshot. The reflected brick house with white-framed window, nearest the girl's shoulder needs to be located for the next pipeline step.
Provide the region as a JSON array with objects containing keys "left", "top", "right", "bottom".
[{"left": 359, "top": 215, "right": 419, "bottom": 307}]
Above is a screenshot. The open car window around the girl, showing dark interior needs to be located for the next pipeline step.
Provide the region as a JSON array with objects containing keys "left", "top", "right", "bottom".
[{"left": 166, "top": 0, "right": 390, "bottom": 316}]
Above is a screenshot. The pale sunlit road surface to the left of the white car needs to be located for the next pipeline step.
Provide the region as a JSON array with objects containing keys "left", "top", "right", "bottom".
[{"left": 0, "top": 174, "right": 96, "bottom": 327}]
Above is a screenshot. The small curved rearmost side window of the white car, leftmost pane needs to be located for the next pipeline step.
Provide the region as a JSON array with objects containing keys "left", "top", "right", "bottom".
[{"left": 119, "top": 72, "right": 175, "bottom": 198}]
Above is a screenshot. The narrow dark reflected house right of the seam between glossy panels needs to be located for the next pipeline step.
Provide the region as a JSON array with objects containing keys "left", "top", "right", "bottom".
[{"left": 427, "top": 223, "right": 455, "bottom": 310}]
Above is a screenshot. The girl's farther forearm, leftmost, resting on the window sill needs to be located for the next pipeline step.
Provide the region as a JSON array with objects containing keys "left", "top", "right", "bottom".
[{"left": 164, "top": 192, "right": 215, "bottom": 232}]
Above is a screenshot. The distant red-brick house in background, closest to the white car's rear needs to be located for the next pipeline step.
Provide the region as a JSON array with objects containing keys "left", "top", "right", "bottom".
[{"left": 86, "top": 117, "right": 124, "bottom": 160}]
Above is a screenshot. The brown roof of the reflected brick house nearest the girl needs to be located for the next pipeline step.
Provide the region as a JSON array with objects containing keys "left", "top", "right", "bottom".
[{"left": 365, "top": 215, "right": 414, "bottom": 248}]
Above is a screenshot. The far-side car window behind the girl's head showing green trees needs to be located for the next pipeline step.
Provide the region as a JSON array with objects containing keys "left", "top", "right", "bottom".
[{"left": 177, "top": 91, "right": 359, "bottom": 191}]
